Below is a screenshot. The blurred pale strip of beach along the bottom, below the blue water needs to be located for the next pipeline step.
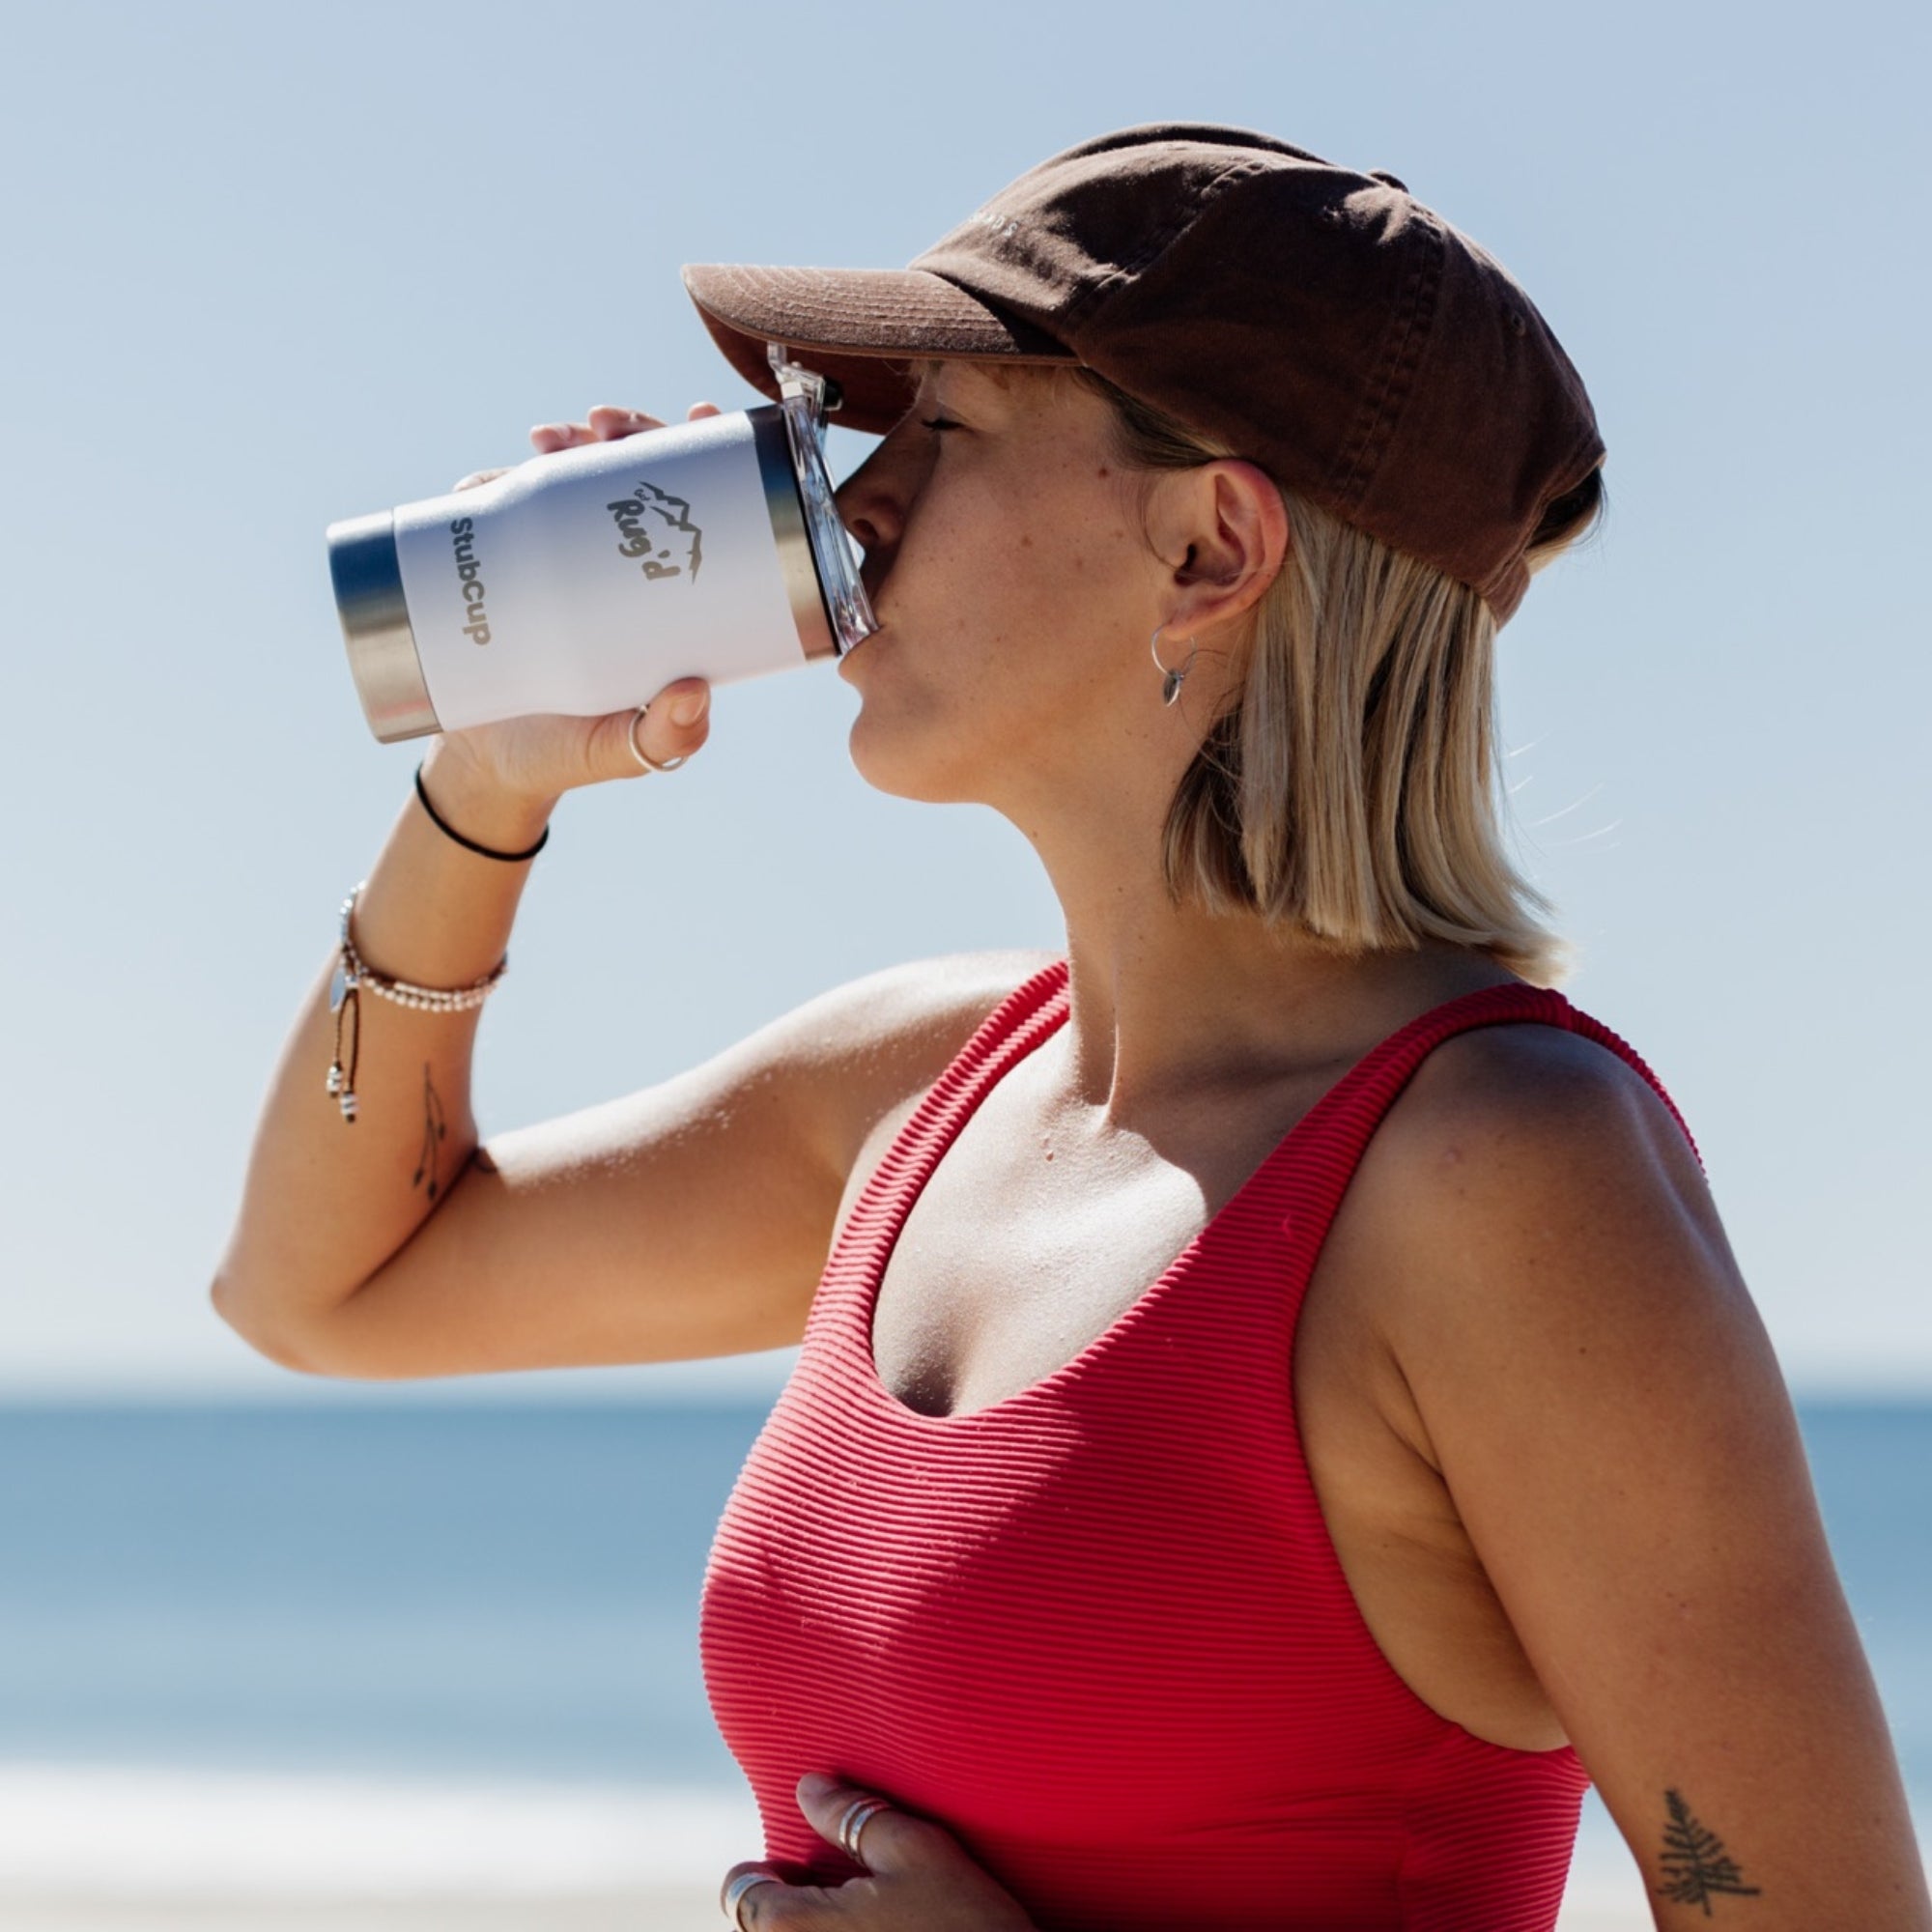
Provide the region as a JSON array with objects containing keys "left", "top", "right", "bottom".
[{"left": 0, "top": 1764, "right": 1650, "bottom": 1932}]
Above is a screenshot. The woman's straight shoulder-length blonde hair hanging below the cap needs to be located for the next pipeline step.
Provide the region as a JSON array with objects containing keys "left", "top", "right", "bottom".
[{"left": 1066, "top": 369, "right": 1604, "bottom": 985}]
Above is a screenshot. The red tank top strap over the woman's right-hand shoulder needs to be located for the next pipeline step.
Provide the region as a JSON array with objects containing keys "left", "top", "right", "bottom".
[{"left": 1279, "top": 985, "right": 1696, "bottom": 1252}]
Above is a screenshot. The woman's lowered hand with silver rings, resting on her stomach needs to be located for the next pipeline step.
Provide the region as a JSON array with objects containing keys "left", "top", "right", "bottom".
[{"left": 721, "top": 1772, "right": 1034, "bottom": 1932}]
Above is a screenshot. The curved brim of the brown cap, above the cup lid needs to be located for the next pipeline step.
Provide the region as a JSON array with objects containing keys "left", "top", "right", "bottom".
[{"left": 684, "top": 265, "right": 1076, "bottom": 435}]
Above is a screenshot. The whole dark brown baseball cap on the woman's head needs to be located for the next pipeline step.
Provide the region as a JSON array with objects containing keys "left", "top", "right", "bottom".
[{"left": 684, "top": 126, "right": 1604, "bottom": 620}]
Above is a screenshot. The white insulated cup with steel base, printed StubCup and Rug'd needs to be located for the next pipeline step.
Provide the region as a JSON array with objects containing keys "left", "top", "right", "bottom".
[{"left": 328, "top": 354, "right": 877, "bottom": 744}]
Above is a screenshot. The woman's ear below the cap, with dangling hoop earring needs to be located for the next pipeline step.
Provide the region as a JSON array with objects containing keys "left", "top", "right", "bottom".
[{"left": 1148, "top": 456, "right": 1289, "bottom": 638}]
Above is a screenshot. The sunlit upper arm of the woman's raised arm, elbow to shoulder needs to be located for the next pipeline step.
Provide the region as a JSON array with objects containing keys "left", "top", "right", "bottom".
[{"left": 294, "top": 954, "right": 1037, "bottom": 1378}]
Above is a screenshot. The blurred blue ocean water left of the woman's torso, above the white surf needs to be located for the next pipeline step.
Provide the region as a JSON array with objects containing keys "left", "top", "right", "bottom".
[{"left": 0, "top": 1401, "right": 763, "bottom": 1785}]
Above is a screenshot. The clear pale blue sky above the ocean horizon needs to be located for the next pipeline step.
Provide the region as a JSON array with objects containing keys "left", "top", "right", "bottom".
[{"left": 0, "top": 0, "right": 1932, "bottom": 1389}]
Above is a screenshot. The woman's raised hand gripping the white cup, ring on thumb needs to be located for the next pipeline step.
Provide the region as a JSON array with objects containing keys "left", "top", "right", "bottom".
[{"left": 431, "top": 402, "right": 719, "bottom": 817}]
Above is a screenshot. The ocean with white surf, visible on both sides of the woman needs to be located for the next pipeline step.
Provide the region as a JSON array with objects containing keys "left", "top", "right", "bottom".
[{"left": 0, "top": 1391, "right": 1932, "bottom": 1889}]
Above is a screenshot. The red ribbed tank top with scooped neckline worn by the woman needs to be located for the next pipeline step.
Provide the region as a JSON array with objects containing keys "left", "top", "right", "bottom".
[{"left": 701, "top": 962, "right": 1692, "bottom": 1932}]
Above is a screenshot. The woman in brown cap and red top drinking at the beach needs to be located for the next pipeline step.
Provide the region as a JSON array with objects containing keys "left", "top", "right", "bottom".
[{"left": 214, "top": 128, "right": 1932, "bottom": 1932}]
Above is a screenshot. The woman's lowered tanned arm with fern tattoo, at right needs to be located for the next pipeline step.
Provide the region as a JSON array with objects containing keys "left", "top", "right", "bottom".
[{"left": 1385, "top": 1028, "right": 1932, "bottom": 1932}]
